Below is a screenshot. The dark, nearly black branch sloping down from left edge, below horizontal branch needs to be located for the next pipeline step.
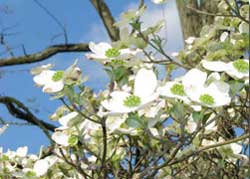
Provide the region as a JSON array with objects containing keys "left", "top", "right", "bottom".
[{"left": 0, "top": 96, "right": 56, "bottom": 132}]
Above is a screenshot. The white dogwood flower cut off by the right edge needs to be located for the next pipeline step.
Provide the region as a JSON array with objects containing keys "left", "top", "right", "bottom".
[{"left": 201, "top": 59, "right": 249, "bottom": 79}]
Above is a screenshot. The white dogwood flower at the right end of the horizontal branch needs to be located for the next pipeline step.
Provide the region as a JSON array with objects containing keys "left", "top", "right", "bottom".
[{"left": 86, "top": 42, "right": 141, "bottom": 63}]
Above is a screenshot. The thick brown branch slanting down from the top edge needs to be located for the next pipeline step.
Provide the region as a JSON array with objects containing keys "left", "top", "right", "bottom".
[{"left": 91, "top": 0, "right": 120, "bottom": 41}]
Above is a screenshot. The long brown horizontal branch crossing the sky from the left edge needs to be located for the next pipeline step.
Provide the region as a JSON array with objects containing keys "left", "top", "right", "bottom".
[{"left": 0, "top": 43, "right": 89, "bottom": 67}]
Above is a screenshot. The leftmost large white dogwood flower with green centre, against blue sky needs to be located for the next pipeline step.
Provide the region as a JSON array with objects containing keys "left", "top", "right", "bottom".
[{"left": 33, "top": 70, "right": 64, "bottom": 93}]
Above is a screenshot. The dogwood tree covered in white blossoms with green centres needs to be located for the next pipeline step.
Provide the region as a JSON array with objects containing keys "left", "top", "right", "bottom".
[{"left": 0, "top": 0, "right": 250, "bottom": 179}]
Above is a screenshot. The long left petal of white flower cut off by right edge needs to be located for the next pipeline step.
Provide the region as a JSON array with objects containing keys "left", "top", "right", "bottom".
[{"left": 201, "top": 60, "right": 228, "bottom": 72}]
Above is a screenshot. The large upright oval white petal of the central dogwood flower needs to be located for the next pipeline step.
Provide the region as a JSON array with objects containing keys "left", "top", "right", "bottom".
[{"left": 134, "top": 68, "right": 157, "bottom": 98}]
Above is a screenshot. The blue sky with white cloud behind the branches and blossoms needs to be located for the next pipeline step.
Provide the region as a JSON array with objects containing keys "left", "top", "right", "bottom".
[{"left": 0, "top": 0, "right": 183, "bottom": 153}]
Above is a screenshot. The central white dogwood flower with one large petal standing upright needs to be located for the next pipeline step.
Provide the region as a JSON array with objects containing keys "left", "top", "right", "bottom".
[{"left": 101, "top": 68, "right": 158, "bottom": 115}]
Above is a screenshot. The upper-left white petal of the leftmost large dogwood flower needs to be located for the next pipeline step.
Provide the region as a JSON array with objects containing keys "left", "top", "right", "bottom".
[{"left": 33, "top": 70, "right": 56, "bottom": 86}]
